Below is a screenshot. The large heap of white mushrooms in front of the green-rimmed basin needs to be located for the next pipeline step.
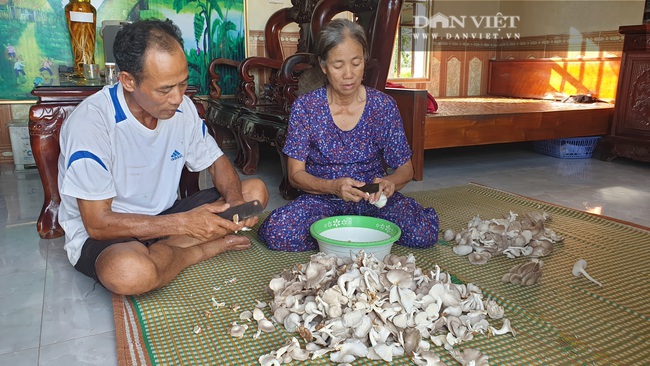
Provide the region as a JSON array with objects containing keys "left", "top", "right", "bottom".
[{"left": 259, "top": 252, "right": 515, "bottom": 365}]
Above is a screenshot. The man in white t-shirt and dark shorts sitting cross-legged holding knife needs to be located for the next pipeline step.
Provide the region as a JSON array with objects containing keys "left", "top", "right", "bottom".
[{"left": 59, "top": 20, "right": 268, "bottom": 295}]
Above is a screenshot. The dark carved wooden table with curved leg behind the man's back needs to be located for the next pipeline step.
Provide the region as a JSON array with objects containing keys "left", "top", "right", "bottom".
[{"left": 29, "top": 79, "right": 204, "bottom": 239}]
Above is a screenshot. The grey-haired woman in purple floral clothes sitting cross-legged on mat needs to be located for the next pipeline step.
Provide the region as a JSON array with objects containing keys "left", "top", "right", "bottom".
[{"left": 258, "top": 19, "right": 438, "bottom": 251}]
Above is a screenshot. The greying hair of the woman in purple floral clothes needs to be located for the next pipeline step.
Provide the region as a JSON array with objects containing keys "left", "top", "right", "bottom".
[{"left": 316, "top": 19, "right": 368, "bottom": 66}]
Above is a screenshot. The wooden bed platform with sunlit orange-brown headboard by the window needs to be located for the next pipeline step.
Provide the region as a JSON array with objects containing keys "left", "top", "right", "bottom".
[{"left": 386, "top": 59, "right": 620, "bottom": 180}]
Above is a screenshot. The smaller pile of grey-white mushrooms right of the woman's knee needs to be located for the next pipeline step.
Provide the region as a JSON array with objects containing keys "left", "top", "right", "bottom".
[{"left": 443, "top": 211, "right": 562, "bottom": 264}]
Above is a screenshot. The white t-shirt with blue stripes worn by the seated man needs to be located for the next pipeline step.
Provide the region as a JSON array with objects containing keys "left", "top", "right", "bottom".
[{"left": 58, "top": 83, "right": 223, "bottom": 265}]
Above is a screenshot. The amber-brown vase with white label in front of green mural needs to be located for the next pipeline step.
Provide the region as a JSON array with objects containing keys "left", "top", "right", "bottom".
[{"left": 65, "top": 0, "right": 97, "bottom": 75}]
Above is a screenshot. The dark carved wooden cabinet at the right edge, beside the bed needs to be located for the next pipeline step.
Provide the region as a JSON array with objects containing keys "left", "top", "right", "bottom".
[{"left": 600, "top": 24, "right": 650, "bottom": 161}]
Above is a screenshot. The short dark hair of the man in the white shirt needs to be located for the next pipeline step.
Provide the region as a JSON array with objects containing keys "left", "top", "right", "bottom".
[{"left": 113, "top": 19, "right": 183, "bottom": 83}]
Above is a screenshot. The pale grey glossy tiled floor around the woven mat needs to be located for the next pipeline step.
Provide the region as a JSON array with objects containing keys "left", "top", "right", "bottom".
[{"left": 0, "top": 144, "right": 650, "bottom": 366}]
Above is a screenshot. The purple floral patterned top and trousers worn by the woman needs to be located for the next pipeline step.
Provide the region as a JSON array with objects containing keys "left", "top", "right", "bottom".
[{"left": 258, "top": 87, "right": 438, "bottom": 252}]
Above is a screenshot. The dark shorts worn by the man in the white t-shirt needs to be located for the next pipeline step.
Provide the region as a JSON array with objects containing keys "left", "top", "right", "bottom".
[{"left": 74, "top": 188, "right": 221, "bottom": 283}]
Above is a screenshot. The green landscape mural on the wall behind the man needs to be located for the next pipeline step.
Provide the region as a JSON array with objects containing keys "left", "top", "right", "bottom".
[{"left": 0, "top": 0, "right": 246, "bottom": 101}]
